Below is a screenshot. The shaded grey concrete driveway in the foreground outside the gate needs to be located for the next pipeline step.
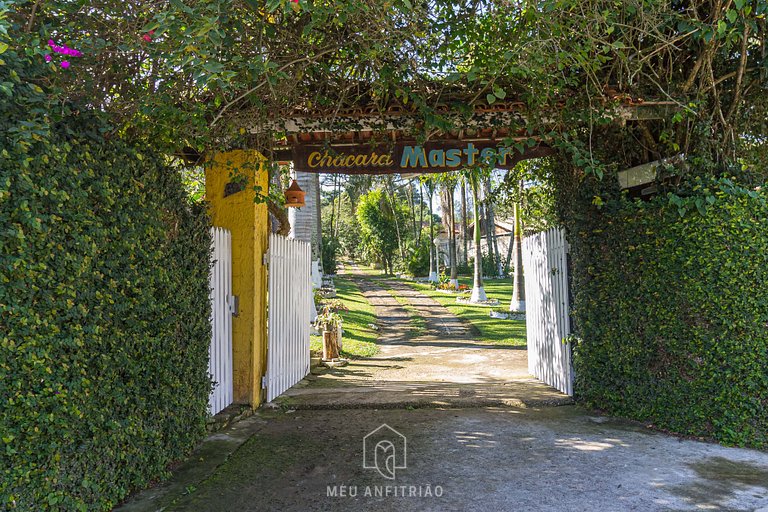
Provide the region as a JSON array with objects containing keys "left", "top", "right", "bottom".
[{"left": 118, "top": 406, "right": 768, "bottom": 512}]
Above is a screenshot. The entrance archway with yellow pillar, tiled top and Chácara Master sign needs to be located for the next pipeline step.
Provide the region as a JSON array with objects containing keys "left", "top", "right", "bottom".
[{"left": 206, "top": 99, "right": 667, "bottom": 406}]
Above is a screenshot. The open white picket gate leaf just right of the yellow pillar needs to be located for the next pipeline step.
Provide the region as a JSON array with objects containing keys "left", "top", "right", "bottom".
[{"left": 265, "top": 233, "right": 312, "bottom": 402}]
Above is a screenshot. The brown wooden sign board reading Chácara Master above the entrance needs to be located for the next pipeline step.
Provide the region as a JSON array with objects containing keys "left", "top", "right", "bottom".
[{"left": 293, "top": 141, "right": 552, "bottom": 174}]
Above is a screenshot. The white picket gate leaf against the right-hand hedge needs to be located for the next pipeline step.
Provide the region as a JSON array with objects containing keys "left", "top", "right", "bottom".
[{"left": 522, "top": 228, "right": 573, "bottom": 395}]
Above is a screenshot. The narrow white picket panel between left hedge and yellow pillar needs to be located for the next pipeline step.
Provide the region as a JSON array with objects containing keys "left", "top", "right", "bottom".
[{"left": 208, "top": 228, "right": 233, "bottom": 414}]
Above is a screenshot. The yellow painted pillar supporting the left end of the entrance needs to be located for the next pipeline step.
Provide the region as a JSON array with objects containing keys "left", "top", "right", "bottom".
[{"left": 205, "top": 150, "right": 269, "bottom": 407}]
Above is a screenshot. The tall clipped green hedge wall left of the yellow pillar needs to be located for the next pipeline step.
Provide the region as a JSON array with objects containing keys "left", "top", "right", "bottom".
[{"left": 0, "top": 52, "right": 210, "bottom": 511}]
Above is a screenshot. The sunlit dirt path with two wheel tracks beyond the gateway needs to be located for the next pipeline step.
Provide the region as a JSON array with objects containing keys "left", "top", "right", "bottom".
[{"left": 283, "top": 274, "right": 570, "bottom": 408}]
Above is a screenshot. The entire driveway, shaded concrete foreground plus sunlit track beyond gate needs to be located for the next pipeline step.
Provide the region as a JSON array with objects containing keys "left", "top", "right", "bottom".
[{"left": 120, "top": 276, "right": 768, "bottom": 512}]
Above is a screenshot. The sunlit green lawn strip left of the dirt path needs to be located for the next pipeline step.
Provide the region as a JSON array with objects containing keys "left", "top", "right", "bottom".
[{"left": 309, "top": 277, "right": 379, "bottom": 358}]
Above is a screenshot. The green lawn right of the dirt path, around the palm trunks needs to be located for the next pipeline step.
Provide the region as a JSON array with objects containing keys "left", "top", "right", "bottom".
[{"left": 403, "top": 277, "right": 526, "bottom": 346}]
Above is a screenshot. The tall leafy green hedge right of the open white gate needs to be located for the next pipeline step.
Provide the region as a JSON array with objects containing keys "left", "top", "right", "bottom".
[{"left": 570, "top": 180, "right": 768, "bottom": 448}]
